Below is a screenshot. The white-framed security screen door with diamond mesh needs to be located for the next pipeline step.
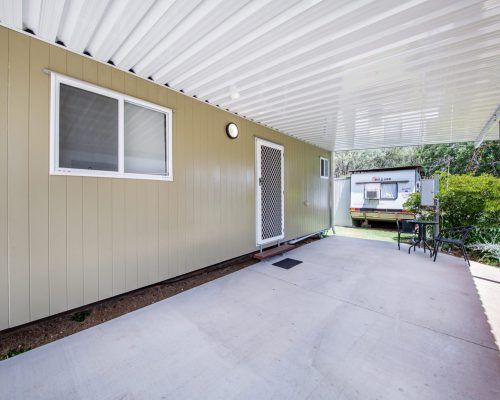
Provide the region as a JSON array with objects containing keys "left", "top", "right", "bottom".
[{"left": 255, "top": 139, "right": 285, "bottom": 245}]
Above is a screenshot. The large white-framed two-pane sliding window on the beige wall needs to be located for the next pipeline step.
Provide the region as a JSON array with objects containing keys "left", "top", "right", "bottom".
[{"left": 50, "top": 72, "right": 173, "bottom": 181}]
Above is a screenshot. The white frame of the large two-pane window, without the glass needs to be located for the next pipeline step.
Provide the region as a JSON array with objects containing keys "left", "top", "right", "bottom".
[{"left": 49, "top": 72, "right": 174, "bottom": 181}]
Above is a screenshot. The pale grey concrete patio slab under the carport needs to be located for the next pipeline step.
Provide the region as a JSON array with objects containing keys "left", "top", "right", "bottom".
[{"left": 0, "top": 237, "right": 500, "bottom": 400}]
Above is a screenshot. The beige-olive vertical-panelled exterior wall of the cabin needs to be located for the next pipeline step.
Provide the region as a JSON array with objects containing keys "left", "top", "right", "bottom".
[{"left": 0, "top": 27, "right": 329, "bottom": 330}]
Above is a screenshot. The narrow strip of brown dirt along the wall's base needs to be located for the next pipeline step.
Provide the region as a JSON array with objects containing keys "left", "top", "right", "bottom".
[{"left": 0, "top": 238, "right": 318, "bottom": 360}]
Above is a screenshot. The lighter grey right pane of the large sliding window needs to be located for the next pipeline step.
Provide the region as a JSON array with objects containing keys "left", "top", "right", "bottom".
[{"left": 124, "top": 102, "right": 168, "bottom": 175}]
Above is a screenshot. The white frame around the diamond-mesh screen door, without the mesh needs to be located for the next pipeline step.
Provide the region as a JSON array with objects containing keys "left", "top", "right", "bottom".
[{"left": 255, "top": 138, "right": 285, "bottom": 246}]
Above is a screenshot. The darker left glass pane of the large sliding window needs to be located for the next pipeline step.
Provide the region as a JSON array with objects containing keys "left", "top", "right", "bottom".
[{"left": 59, "top": 83, "right": 118, "bottom": 171}]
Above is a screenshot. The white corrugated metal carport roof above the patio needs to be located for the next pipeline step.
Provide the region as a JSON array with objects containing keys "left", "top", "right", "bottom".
[{"left": 0, "top": 0, "right": 500, "bottom": 150}]
